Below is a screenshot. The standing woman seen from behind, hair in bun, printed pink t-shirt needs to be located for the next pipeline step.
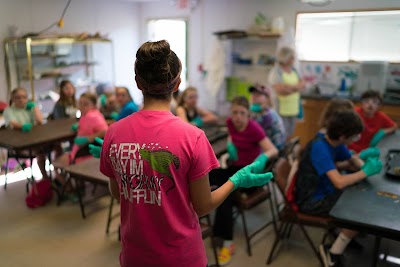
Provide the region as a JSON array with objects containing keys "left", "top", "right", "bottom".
[{"left": 95, "top": 40, "right": 272, "bottom": 267}]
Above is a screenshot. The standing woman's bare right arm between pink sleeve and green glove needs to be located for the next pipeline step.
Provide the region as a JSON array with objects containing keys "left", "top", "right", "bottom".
[{"left": 189, "top": 174, "right": 234, "bottom": 217}]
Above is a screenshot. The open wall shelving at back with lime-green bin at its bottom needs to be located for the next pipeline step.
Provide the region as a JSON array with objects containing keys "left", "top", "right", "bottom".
[{"left": 218, "top": 34, "right": 280, "bottom": 115}]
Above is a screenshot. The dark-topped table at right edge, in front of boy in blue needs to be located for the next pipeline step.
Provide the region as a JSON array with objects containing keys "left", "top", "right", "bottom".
[{"left": 330, "top": 131, "right": 400, "bottom": 266}]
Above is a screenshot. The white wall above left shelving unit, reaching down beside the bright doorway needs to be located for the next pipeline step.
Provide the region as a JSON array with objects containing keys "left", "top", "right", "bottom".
[{"left": 0, "top": 0, "right": 141, "bottom": 102}]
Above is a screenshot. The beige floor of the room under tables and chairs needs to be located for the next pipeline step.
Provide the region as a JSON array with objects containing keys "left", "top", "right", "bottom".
[{"left": 0, "top": 170, "right": 400, "bottom": 267}]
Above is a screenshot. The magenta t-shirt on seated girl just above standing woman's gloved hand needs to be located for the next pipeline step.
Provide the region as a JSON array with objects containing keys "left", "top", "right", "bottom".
[{"left": 226, "top": 118, "right": 265, "bottom": 166}]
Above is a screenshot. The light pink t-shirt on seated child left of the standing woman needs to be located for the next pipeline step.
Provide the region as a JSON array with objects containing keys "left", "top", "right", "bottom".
[{"left": 70, "top": 109, "right": 108, "bottom": 160}]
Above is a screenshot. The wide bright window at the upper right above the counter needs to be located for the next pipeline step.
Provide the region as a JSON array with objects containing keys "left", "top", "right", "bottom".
[{"left": 296, "top": 10, "right": 400, "bottom": 62}]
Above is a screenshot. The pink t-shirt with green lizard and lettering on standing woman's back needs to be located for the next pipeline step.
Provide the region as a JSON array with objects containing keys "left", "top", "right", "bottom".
[{"left": 100, "top": 110, "right": 219, "bottom": 267}]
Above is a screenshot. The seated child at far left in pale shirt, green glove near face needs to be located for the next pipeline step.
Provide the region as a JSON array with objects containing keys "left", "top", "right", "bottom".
[{"left": 3, "top": 87, "right": 49, "bottom": 178}]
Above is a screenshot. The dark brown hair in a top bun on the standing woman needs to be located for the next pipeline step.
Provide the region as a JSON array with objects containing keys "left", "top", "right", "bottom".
[{"left": 135, "top": 40, "right": 182, "bottom": 99}]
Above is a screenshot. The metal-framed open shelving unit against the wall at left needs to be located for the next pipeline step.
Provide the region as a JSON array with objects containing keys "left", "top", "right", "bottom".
[{"left": 4, "top": 37, "right": 114, "bottom": 114}]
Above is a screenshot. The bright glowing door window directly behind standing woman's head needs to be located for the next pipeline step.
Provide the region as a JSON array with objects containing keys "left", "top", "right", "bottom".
[{"left": 147, "top": 19, "right": 188, "bottom": 88}]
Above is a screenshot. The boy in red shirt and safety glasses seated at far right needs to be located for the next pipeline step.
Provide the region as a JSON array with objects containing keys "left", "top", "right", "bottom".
[{"left": 349, "top": 90, "right": 397, "bottom": 153}]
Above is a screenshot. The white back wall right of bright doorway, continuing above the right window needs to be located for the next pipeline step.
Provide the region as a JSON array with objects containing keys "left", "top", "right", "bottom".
[{"left": 139, "top": 0, "right": 399, "bottom": 110}]
